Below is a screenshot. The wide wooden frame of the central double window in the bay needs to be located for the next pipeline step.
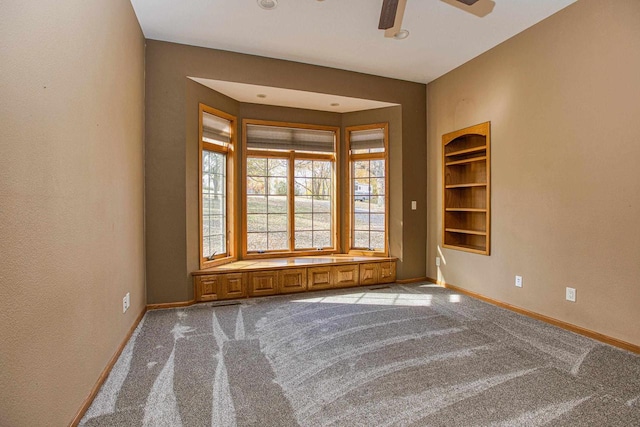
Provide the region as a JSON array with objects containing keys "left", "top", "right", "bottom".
[{"left": 241, "top": 119, "right": 341, "bottom": 259}]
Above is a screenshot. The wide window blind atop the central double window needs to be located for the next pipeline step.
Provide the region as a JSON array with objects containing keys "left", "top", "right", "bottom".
[{"left": 247, "top": 124, "right": 336, "bottom": 153}]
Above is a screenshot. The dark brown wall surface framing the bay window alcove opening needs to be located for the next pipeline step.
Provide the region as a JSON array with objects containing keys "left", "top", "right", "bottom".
[{"left": 145, "top": 40, "right": 426, "bottom": 303}]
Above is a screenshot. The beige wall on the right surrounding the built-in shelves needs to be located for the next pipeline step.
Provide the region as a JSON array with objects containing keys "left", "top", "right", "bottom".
[{"left": 427, "top": 0, "right": 640, "bottom": 345}]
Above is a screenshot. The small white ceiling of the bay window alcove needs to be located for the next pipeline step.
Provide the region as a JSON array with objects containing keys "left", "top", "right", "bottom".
[{"left": 189, "top": 77, "right": 398, "bottom": 113}]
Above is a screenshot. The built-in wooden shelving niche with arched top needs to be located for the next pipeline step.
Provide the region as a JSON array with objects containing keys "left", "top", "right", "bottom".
[{"left": 442, "top": 122, "right": 491, "bottom": 255}]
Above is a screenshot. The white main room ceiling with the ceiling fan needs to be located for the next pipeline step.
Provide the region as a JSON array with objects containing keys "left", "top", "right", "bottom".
[{"left": 131, "top": 0, "right": 576, "bottom": 83}]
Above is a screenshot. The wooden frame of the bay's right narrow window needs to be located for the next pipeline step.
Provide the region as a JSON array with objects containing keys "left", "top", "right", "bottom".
[{"left": 345, "top": 122, "right": 390, "bottom": 256}]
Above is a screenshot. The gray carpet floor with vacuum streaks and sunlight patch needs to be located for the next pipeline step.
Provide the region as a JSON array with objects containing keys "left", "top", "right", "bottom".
[{"left": 81, "top": 283, "right": 640, "bottom": 426}]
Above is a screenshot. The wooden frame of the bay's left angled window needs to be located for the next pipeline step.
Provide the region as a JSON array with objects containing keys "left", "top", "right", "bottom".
[{"left": 198, "top": 103, "right": 238, "bottom": 269}]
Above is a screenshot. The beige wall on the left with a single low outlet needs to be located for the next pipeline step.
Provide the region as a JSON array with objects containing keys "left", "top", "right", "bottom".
[{"left": 0, "top": 0, "right": 145, "bottom": 426}]
